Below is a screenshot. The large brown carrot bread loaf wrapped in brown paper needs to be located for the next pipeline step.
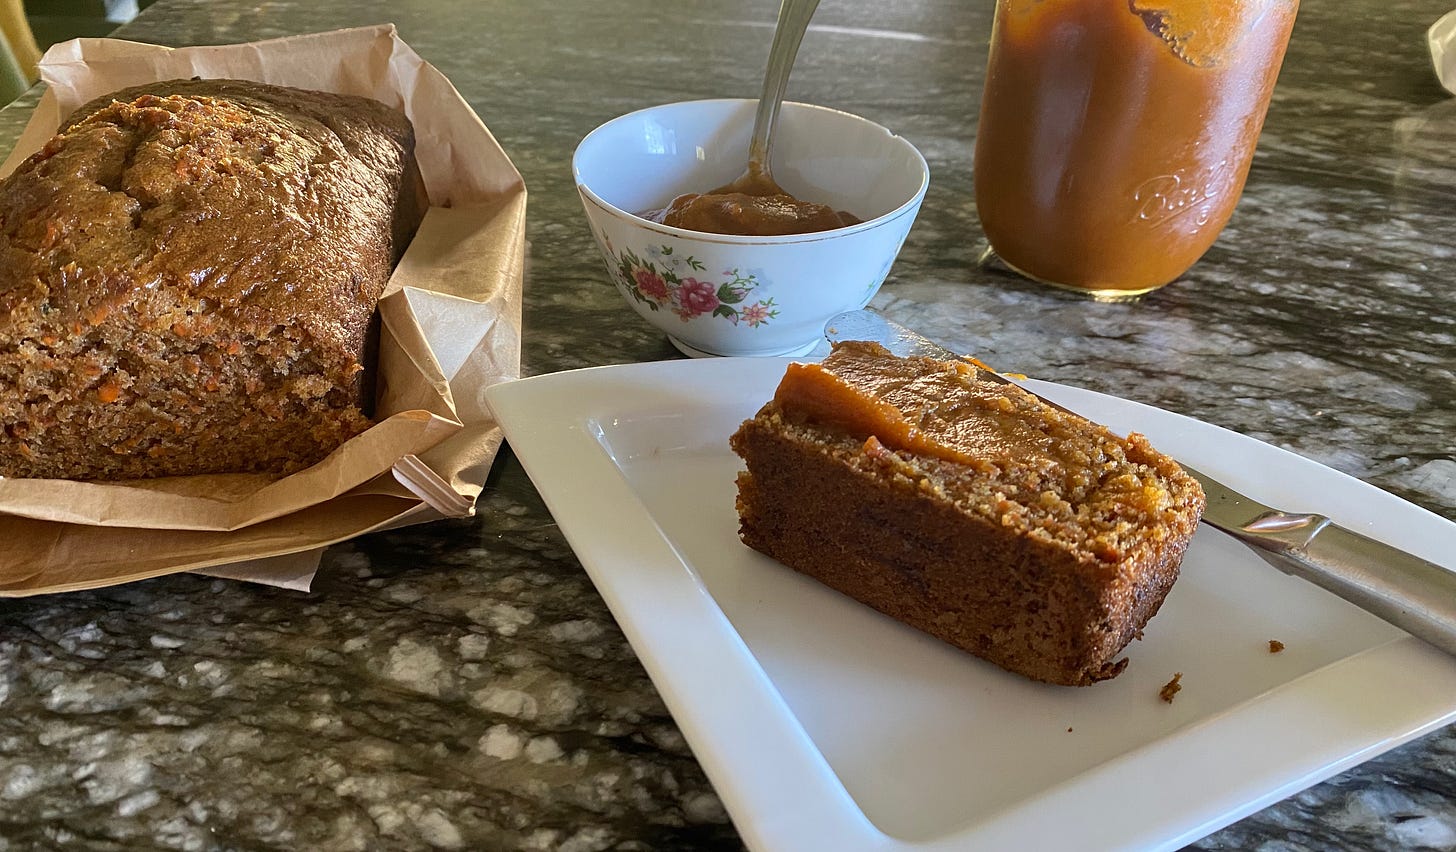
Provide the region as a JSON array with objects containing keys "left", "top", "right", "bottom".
[{"left": 0, "top": 80, "right": 427, "bottom": 479}]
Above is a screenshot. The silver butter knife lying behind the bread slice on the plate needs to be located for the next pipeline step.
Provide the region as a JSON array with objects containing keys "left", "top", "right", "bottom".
[{"left": 824, "top": 310, "right": 1456, "bottom": 655}]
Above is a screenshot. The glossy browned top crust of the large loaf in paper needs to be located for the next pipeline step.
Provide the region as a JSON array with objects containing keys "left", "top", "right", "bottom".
[{"left": 0, "top": 80, "right": 418, "bottom": 362}]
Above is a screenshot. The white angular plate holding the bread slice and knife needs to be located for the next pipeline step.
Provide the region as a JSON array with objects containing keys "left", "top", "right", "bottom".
[{"left": 489, "top": 358, "right": 1456, "bottom": 852}]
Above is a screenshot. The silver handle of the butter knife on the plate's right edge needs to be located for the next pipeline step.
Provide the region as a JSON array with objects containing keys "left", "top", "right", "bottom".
[{"left": 1236, "top": 516, "right": 1456, "bottom": 655}]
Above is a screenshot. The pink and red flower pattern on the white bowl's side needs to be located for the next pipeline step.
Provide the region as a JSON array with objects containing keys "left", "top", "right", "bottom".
[{"left": 603, "top": 240, "right": 779, "bottom": 328}]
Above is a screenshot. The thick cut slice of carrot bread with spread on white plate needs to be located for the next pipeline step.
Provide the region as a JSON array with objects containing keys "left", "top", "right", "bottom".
[{"left": 732, "top": 342, "right": 1204, "bottom": 686}]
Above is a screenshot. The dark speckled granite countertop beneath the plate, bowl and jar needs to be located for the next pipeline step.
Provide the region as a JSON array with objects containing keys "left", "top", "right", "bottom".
[{"left": 0, "top": 0, "right": 1456, "bottom": 852}]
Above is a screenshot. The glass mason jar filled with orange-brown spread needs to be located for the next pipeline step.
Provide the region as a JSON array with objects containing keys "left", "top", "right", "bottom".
[{"left": 976, "top": 0, "right": 1299, "bottom": 299}]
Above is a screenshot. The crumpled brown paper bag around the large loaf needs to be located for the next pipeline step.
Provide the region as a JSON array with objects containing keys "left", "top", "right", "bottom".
[{"left": 0, "top": 25, "right": 526, "bottom": 596}]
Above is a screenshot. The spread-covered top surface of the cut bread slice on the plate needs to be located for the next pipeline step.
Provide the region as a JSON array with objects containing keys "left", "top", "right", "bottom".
[{"left": 772, "top": 341, "right": 1204, "bottom": 564}]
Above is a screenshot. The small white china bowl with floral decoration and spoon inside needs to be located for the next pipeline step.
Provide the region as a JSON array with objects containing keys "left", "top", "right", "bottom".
[{"left": 572, "top": 100, "right": 930, "bottom": 355}]
